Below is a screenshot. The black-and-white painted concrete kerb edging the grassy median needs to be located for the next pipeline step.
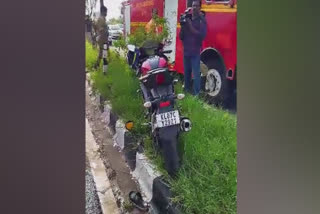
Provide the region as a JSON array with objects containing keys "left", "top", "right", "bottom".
[{"left": 89, "top": 79, "right": 180, "bottom": 214}]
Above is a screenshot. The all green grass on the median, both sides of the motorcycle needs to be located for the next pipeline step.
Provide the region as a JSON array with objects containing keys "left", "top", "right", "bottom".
[{"left": 86, "top": 42, "right": 237, "bottom": 214}]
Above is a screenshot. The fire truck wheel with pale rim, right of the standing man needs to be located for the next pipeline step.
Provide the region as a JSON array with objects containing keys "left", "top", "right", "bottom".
[{"left": 204, "top": 68, "right": 226, "bottom": 105}]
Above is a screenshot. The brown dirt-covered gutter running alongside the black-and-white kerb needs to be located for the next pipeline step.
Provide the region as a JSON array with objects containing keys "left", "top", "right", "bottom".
[{"left": 86, "top": 80, "right": 147, "bottom": 214}]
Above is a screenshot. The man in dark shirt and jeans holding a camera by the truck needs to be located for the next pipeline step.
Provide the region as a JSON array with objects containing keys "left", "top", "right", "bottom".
[{"left": 179, "top": 0, "right": 207, "bottom": 96}]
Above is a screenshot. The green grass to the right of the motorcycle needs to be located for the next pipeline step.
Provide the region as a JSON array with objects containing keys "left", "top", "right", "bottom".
[{"left": 172, "top": 91, "right": 237, "bottom": 214}]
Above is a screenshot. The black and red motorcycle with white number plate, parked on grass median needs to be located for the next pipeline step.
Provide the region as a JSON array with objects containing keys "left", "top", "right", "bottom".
[{"left": 127, "top": 42, "right": 191, "bottom": 176}]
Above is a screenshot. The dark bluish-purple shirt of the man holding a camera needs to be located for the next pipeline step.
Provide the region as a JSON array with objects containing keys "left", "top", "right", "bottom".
[{"left": 179, "top": 16, "right": 207, "bottom": 56}]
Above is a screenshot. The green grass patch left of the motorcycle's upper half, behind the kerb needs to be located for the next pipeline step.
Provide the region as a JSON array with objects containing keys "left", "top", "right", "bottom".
[{"left": 86, "top": 42, "right": 147, "bottom": 134}]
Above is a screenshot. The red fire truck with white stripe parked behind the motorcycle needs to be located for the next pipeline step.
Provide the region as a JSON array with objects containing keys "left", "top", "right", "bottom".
[{"left": 122, "top": 0, "right": 237, "bottom": 107}]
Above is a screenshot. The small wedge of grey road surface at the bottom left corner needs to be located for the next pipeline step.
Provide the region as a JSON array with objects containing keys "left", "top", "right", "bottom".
[{"left": 86, "top": 168, "right": 102, "bottom": 214}]
